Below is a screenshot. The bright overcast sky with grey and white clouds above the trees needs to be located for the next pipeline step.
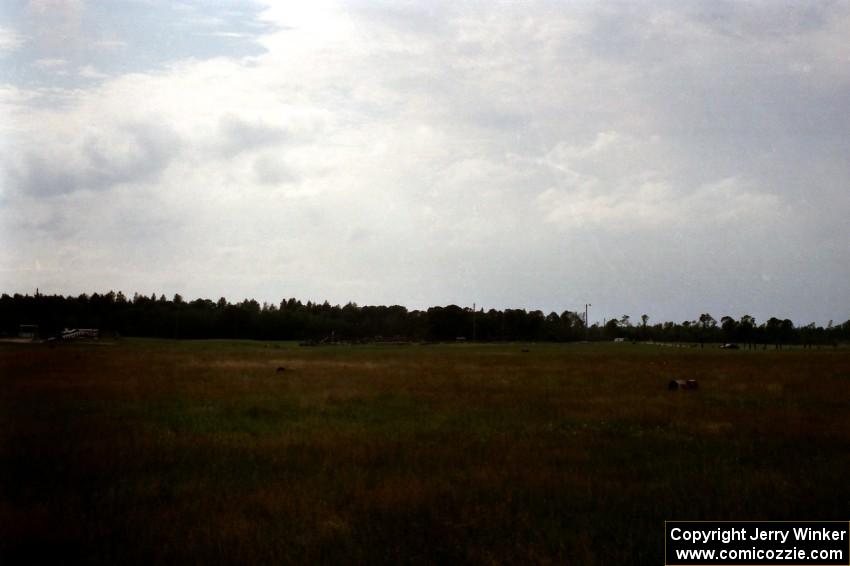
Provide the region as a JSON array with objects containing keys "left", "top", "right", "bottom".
[{"left": 0, "top": 0, "right": 850, "bottom": 324}]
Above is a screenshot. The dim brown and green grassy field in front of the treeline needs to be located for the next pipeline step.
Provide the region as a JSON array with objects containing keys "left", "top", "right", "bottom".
[{"left": 0, "top": 340, "right": 850, "bottom": 566}]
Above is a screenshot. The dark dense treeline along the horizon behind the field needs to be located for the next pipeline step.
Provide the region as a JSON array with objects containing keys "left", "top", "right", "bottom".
[{"left": 0, "top": 291, "right": 850, "bottom": 345}]
